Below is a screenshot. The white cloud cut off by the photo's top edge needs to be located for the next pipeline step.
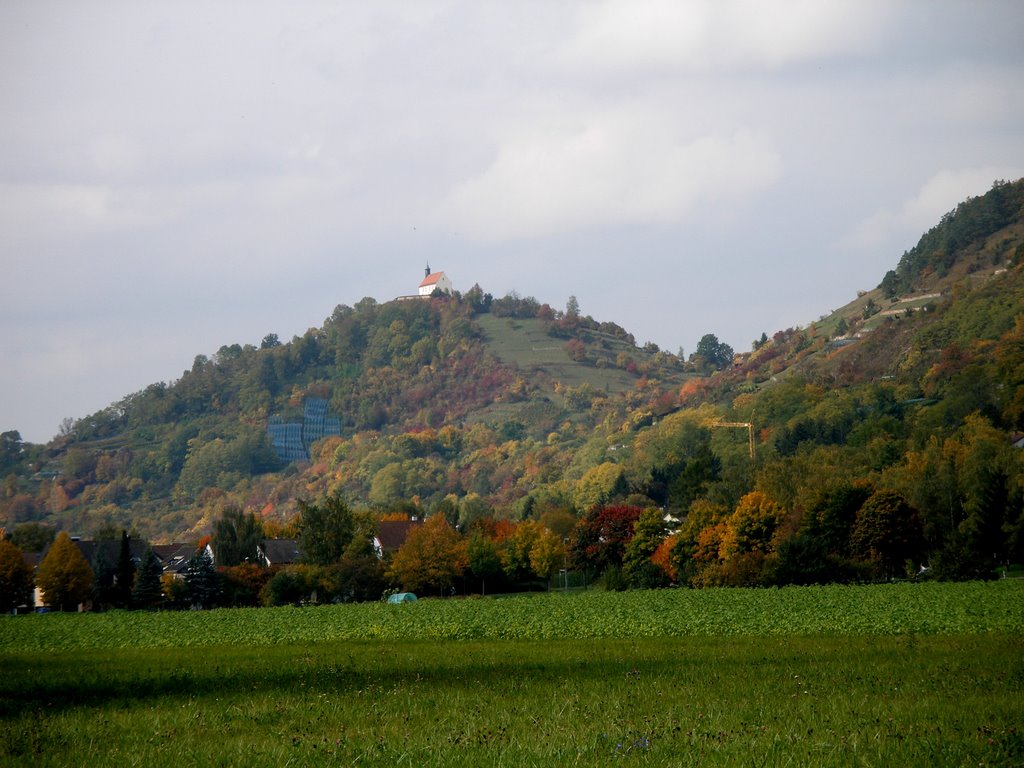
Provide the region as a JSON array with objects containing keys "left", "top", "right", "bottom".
[{"left": 565, "top": 0, "right": 887, "bottom": 72}]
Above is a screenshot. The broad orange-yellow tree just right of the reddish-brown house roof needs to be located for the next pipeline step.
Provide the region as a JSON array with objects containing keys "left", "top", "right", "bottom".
[{"left": 387, "top": 515, "right": 469, "bottom": 594}]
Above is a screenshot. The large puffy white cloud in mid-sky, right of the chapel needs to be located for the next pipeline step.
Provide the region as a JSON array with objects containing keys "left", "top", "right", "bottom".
[{"left": 440, "top": 113, "right": 782, "bottom": 241}]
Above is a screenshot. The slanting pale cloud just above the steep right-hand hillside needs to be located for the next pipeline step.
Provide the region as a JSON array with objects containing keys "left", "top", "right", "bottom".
[{"left": 841, "top": 166, "right": 1024, "bottom": 250}]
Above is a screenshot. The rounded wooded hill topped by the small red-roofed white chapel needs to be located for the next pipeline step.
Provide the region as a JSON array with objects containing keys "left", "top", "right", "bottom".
[{"left": 0, "top": 287, "right": 688, "bottom": 539}]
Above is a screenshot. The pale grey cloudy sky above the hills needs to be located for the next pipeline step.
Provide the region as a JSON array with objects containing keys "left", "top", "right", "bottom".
[{"left": 0, "top": 0, "right": 1024, "bottom": 442}]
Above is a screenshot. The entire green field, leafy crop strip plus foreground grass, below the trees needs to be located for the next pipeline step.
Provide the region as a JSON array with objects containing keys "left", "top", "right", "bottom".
[{"left": 0, "top": 582, "right": 1024, "bottom": 766}]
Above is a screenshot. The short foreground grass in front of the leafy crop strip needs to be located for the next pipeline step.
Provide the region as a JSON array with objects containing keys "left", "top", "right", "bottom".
[{"left": 0, "top": 635, "right": 1024, "bottom": 766}]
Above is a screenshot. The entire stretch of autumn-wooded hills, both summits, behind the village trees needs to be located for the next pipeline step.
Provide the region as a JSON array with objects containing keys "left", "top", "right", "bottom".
[{"left": 0, "top": 180, "right": 1024, "bottom": 583}]
